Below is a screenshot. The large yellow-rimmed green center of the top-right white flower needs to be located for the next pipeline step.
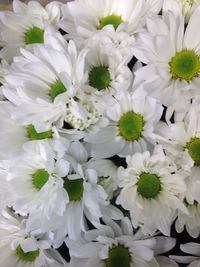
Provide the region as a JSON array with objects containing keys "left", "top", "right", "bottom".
[{"left": 169, "top": 49, "right": 200, "bottom": 82}]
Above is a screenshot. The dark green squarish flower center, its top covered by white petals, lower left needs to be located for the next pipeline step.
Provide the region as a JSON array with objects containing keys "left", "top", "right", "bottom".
[{"left": 64, "top": 178, "right": 84, "bottom": 201}]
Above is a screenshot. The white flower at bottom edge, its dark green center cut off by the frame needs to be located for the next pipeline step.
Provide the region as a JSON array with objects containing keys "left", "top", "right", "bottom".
[{"left": 66, "top": 217, "right": 177, "bottom": 267}]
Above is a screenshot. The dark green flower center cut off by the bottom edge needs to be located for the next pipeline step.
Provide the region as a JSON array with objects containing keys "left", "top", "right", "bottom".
[{"left": 105, "top": 245, "right": 131, "bottom": 267}]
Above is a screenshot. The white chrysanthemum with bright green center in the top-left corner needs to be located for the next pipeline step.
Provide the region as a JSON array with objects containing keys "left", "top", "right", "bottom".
[{"left": 0, "top": 0, "right": 60, "bottom": 62}]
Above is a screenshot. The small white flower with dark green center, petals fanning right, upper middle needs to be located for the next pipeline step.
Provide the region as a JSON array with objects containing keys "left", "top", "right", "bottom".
[{"left": 85, "top": 41, "right": 132, "bottom": 101}]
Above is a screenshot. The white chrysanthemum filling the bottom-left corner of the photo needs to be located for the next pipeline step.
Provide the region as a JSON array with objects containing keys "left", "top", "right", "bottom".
[{"left": 0, "top": 211, "right": 66, "bottom": 267}]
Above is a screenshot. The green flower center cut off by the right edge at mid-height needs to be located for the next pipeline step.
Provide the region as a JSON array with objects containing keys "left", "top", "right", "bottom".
[{"left": 186, "top": 137, "right": 200, "bottom": 166}]
